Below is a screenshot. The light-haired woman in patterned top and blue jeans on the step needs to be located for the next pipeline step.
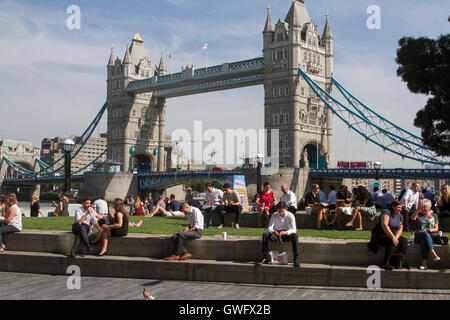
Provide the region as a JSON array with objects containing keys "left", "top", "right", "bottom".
[{"left": 411, "top": 199, "right": 441, "bottom": 270}]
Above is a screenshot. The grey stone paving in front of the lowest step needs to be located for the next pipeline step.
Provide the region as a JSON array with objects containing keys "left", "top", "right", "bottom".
[{"left": 0, "top": 272, "right": 450, "bottom": 300}]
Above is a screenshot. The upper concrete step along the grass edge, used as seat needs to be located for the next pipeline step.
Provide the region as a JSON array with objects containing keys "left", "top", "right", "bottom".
[{"left": 5, "top": 231, "right": 450, "bottom": 269}]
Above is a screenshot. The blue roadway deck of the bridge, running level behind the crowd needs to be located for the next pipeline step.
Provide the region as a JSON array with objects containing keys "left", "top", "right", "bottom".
[{"left": 3, "top": 169, "right": 450, "bottom": 189}]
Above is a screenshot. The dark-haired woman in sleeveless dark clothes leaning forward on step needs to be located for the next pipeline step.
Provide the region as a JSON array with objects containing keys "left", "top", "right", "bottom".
[{"left": 367, "top": 200, "right": 410, "bottom": 270}]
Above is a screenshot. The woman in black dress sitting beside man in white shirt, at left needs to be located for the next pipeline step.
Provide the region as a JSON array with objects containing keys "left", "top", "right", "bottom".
[{"left": 98, "top": 198, "right": 130, "bottom": 257}]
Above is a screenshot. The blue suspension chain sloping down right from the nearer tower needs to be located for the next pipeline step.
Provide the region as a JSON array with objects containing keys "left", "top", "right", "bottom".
[{"left": 298, "top": 66, "right": 450, "bottom": 165}]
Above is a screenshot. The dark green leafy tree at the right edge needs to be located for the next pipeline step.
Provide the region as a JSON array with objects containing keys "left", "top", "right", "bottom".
[{"left": 396, "top": 34, "right": 450, "bottom": 156}]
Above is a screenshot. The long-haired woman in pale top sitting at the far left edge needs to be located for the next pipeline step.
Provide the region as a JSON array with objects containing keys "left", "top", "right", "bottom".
[{"left": 0, "top": 193, "right": 22, "bottom": 252}]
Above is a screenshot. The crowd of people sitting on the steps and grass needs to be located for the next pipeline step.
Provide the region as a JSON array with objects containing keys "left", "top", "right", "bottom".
[{"left": 0, "top": 182, "right": 450, "bottom": 270}]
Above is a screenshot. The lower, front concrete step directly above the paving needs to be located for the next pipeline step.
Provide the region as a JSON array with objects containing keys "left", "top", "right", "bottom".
[{"left": 0, "top": 251, "right": 450, "bottom": 289}]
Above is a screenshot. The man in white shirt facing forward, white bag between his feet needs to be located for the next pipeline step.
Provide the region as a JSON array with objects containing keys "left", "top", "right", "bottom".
[{"left": 257, "top": 202, "right": 300, "bottom": 267}]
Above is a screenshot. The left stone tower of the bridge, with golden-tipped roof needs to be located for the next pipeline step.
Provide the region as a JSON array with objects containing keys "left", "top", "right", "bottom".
[{"left": 107, "top": 33, "right": 167, "bottom": 172}]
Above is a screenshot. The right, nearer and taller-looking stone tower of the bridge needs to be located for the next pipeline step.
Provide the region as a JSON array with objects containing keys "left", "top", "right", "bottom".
[{"left": 263, "top": 0, "right": 333, "bottom": 168}]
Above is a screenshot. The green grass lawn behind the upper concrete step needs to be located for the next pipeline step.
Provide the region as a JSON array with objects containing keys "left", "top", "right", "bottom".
[{"left": 22, "top": 216, "right": 410, "bottom": 240}]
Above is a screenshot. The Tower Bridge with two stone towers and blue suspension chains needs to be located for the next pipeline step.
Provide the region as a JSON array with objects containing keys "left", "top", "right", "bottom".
[{"left": 1, "top": 0, "right": 450, "bottom": 200}]
